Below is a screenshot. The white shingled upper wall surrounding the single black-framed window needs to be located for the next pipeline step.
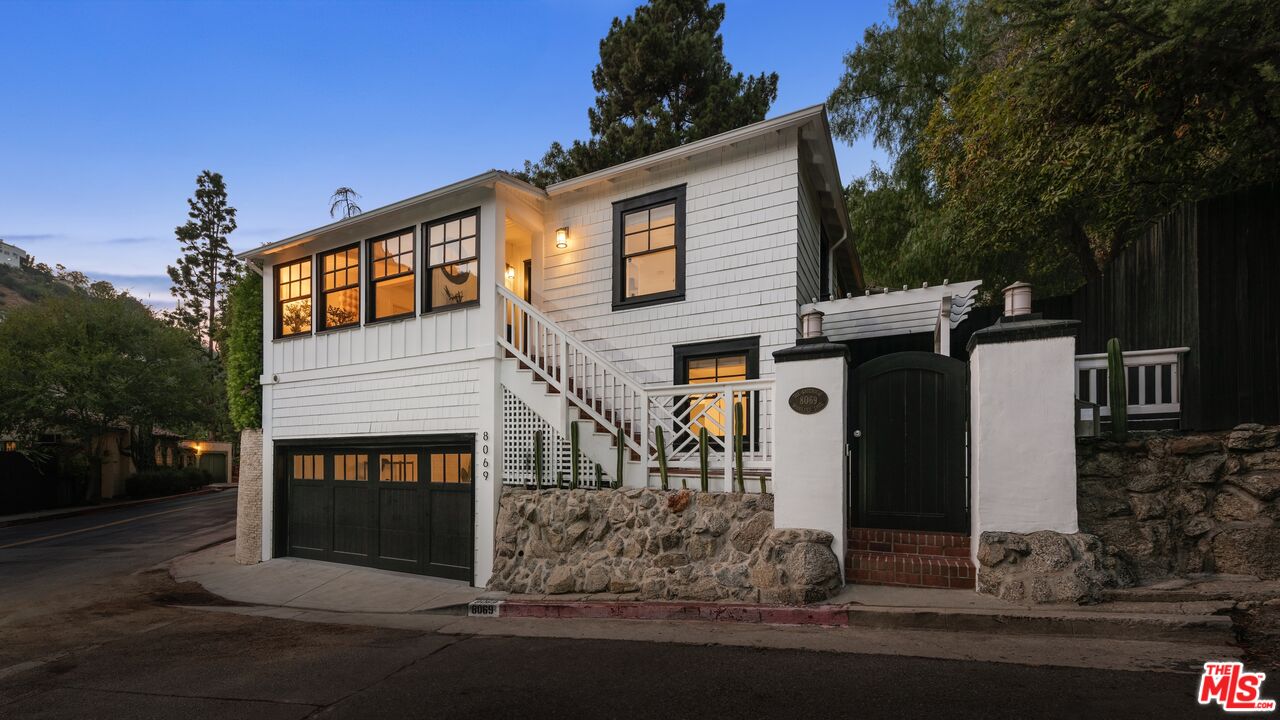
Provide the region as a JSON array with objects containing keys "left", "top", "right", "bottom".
[{"left": 535, "top": 133, "right": 800, "bottom": 384}]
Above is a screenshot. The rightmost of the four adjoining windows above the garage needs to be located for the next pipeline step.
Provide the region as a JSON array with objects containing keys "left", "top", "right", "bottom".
[{"left": 424, "top": 210, "right": 480, "bottom": 311}]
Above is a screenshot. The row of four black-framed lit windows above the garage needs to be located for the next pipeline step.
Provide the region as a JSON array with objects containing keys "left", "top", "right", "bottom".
[{"left": 275, "top": 210, "right": 480, "bottom": 337}]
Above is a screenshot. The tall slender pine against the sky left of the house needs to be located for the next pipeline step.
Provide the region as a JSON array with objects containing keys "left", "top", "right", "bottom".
[{"left": 169, "top": 170, "right": 239, "bottom": 354}]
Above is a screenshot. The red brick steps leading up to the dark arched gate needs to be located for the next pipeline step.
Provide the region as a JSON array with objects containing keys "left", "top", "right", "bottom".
[{"left": 845, "top": 528, "right": 978, "bottom": 589}]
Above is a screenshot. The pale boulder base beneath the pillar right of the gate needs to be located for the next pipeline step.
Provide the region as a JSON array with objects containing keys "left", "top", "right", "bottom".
[{"left": 978, "top": 530, "right": 1134, "bottom": 603}]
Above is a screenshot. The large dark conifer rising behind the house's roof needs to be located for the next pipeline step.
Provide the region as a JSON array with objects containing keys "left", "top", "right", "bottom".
[{"left": 516, "top": 0, "right": 778, "bottom": 187}]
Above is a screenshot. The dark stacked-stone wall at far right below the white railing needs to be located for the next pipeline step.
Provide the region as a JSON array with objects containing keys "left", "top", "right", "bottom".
[{"left": 1078, "top": 424, "right": 1280, "bottom": 580}]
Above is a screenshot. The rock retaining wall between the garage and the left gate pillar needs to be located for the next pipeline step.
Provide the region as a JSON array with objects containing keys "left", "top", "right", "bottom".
[{"left": 489, "top": 488, "right": 840, "bottom": 605}]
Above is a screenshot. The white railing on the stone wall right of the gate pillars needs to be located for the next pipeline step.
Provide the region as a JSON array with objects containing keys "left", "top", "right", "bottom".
[{"left": 1075, "top": 347, "right": 1190, "bottom": 420}]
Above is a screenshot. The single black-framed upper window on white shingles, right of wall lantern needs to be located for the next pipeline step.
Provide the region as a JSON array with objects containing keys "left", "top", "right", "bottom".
[{"left": 613, "top": 186, "right": 685, "bottom": 309}]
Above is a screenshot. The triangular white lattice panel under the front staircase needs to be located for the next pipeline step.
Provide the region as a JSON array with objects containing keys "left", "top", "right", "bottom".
[{"left": 502, "top": 387, "right": 612, "bottom": 488}]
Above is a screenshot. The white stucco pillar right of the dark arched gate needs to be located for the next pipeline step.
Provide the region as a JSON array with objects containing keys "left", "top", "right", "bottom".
[{"left": 969, "top": 315, "right": 1079, "bottom": 557}]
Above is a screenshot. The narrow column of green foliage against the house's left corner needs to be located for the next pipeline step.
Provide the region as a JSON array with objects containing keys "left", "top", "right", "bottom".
[{"left": 223, "top": 269, "right": 262, "bottom": 430}]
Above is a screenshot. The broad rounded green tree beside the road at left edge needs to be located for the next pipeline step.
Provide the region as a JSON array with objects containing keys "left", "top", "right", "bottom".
[{"left": 0, "top": 283, "right": 218, "bottom": 501}]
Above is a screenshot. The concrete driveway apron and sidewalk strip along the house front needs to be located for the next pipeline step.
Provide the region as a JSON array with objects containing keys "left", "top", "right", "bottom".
[{"left": 170, "top": 543, "right": 1234, "bottom": 646}]
